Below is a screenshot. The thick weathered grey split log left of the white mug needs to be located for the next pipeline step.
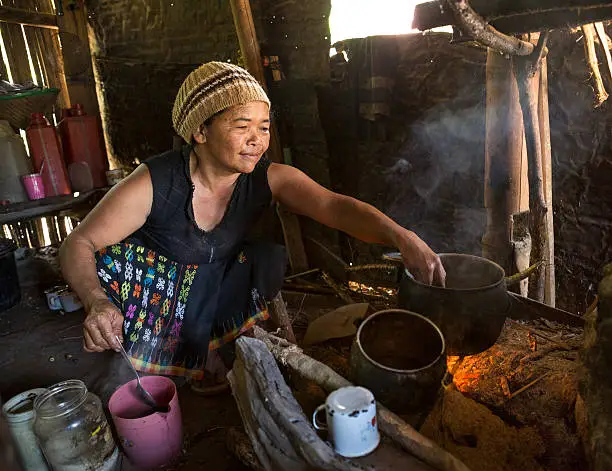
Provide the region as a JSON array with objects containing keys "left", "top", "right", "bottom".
[{"left": 228, "top": 337, "right": 373, "bottom": 471}]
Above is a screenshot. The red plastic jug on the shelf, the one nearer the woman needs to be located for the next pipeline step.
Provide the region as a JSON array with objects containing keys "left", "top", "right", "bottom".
[{"left": 58, "top": 104, "right": 108, "bottom": 191}]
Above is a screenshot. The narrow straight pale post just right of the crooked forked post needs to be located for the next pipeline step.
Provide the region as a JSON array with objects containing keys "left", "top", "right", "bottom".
[{"left": 535, "top": 58, "right": 556, "bottom": 307}]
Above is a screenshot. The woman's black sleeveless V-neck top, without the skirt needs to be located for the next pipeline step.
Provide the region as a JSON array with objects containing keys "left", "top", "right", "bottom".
[{"left": 133, "top": 146, "right": 272, "bottom": 264}]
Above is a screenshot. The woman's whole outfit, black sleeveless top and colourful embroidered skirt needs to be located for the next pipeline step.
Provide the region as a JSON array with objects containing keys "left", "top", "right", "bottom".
[{"left": 110, "top": 146, "right": 287, "bottom": 358}]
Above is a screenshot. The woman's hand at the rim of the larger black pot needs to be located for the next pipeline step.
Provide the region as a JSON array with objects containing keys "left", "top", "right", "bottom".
[{"left": 397, "top": 231, "right": 446, "bottom": 286}]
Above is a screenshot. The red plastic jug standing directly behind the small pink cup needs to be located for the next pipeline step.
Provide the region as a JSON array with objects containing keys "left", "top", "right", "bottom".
[{"left": 26, "top": 113, "right": 72, "bottom": 196}]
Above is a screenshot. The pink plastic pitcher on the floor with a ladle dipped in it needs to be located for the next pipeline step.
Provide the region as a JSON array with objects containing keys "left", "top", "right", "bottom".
[{"left": 108, "top": 376, "right": 183, "bottom": 468}]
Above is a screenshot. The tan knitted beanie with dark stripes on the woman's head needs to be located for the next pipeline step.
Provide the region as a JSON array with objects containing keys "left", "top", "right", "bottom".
[{"left": 172, "top": 62, "right": 270, "bottom": 142}]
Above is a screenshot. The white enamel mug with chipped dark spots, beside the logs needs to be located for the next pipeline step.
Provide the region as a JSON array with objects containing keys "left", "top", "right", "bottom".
[{"left": 312, "top": 386, "right": 380, "bottom": 458}]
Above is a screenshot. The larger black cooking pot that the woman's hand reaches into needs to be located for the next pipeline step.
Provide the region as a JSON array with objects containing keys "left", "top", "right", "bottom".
[{"left": 399, "top": 254, "right": 511, "bottom": 355}]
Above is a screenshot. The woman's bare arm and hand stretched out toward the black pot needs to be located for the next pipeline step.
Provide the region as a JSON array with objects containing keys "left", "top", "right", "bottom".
[{"left": 268, "top": 163, "right": 446, "bottom": 285}]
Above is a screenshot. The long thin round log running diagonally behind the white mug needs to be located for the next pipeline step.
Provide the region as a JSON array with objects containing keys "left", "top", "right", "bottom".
[{"left": 254, "top": 326, "right": 469, "bottom": 471}]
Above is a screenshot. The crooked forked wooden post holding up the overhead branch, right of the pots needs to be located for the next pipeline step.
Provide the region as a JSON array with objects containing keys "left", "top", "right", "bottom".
[{"left": 513, "top": 37, "right": 549, "bottom": 301}]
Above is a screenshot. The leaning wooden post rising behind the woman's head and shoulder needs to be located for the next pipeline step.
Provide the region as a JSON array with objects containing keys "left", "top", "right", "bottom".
[{"left": 230, "top": 0, "right": 308, "bottom": 273}]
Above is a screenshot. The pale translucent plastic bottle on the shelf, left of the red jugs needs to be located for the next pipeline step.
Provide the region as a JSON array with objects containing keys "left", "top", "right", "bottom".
[{"left": 0, "top": 120, "right": 32, "bottom": 203}]
